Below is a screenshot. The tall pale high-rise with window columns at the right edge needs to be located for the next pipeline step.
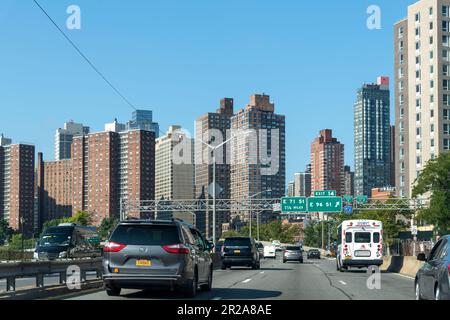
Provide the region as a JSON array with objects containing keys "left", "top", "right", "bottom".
[{"left": 394, "top": 0, "right": 450, "bottom": 198}]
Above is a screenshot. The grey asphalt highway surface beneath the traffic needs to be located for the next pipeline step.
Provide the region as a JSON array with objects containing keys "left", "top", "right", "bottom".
[{"left": 63, "top": 257, "right": 414, "bottom": 300}]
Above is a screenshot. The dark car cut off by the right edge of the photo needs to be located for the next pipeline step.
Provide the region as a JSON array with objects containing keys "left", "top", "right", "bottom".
[{"left": 415, "top": 235, "right": 450, "bottom": 300}]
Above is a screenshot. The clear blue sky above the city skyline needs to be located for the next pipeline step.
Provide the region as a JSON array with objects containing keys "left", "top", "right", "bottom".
[{"left": 0, "top": 0, "right": 414, "bottom": 180}]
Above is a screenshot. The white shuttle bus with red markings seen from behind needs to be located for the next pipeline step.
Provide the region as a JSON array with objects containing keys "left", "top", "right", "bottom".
[{"left": 336, "top": 220, "right": 383, "bottom": 272}]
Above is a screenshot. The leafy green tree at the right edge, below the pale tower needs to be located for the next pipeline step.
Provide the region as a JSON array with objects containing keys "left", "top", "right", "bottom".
[{"left": 413, "top": 152, "right": 450, "bottom": 236}]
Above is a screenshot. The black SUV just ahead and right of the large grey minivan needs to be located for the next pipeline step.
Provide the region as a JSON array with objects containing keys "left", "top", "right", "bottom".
[{"left": 221, "top": 237, "right": 260, "bottom": 270}]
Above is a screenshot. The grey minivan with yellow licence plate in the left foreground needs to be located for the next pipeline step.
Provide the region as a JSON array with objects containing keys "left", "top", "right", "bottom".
[{"left": 103, "top": 220, "right": 213, "bottom": 297}]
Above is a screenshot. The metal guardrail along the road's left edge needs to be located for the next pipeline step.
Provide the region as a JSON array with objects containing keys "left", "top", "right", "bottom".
[{"left": 0, "top": 258, "right": 102, "bottom": 291}]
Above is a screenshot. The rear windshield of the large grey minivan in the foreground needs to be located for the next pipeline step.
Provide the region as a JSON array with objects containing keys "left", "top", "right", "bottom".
[{"left": 110, "top": 225, "right": 181, "bottom": 246}]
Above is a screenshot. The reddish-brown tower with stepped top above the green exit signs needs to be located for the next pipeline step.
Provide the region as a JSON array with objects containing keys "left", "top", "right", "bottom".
[{"left": 311, "top": 129, "right": 345, "bottom": 196}]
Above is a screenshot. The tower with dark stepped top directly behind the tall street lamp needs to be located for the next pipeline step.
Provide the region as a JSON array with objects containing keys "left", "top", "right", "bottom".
[{"left": 195, "top": 98, "right": 234, "bottom": 237}]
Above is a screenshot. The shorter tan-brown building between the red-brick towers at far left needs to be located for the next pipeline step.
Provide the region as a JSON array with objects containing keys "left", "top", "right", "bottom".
[{"left": 36, "top": 153, "right": 73, "bottom": 229}]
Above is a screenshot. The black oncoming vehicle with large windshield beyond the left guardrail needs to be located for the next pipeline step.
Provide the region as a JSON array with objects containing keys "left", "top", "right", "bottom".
[{"left": 34, "top": 223, "right": 102, "bottom": 260}]
